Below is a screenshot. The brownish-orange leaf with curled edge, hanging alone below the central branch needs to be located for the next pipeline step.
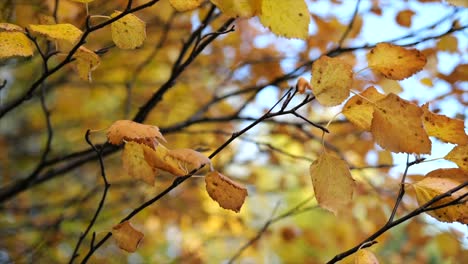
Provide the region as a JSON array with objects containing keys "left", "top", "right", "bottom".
[{"left": 205, "top": 171, "right": 247, "bottom": 213}]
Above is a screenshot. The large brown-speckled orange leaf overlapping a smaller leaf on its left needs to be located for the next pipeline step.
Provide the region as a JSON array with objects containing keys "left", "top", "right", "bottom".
[{"left": 371, "top": 94, "right": 431, "bottom": 154}]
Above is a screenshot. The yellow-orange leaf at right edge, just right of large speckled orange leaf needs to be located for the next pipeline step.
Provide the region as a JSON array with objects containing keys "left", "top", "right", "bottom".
[{"left": 422, "top": 104, "right": 468, "bottom": 145}]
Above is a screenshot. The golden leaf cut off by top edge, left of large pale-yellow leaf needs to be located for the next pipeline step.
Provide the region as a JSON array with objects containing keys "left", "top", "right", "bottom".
[{"left": 210, "top": 0, "right": 261, "bottom": 18}]
